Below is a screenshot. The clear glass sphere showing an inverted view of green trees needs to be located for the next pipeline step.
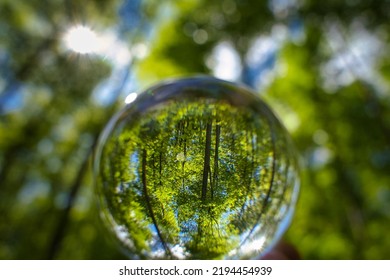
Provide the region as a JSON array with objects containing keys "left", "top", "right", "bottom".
[{"left": 94, "top": 77, "right": 299, "bottom": 259}]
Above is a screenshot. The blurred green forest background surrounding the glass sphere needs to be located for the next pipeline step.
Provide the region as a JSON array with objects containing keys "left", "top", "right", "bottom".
[{"left": 0, "top": 0, "right": 390, "bottom": 259}]
